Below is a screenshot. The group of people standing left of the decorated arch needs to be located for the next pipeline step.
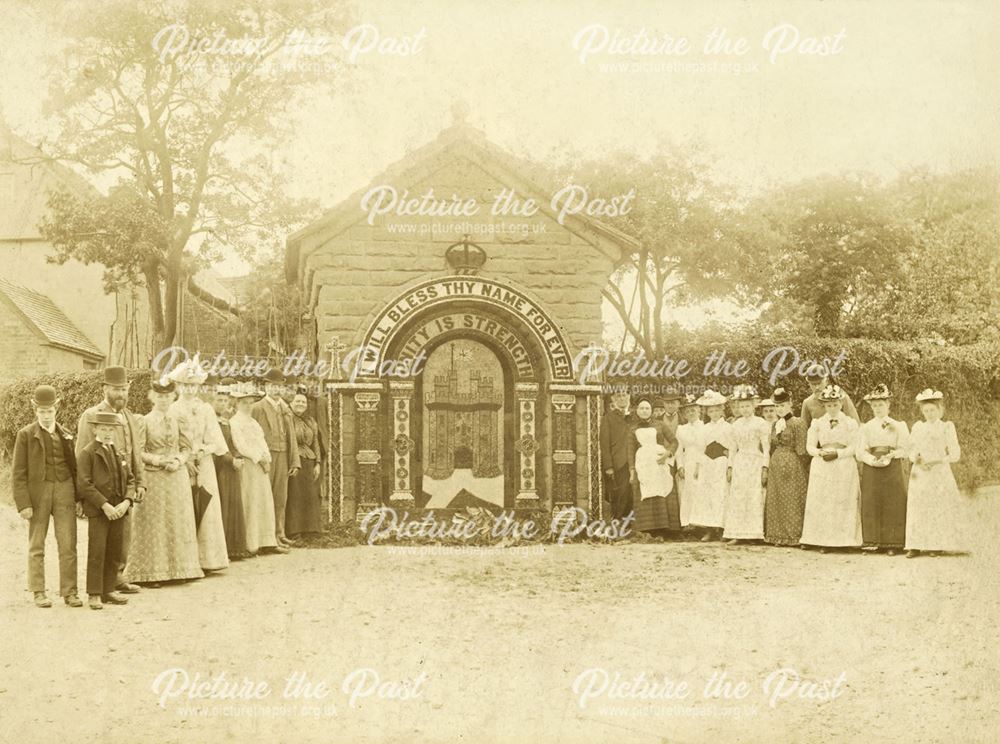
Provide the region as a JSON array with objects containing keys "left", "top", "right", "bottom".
[{"left": 11, "top": 359, "right": 325, "bottom": 610}]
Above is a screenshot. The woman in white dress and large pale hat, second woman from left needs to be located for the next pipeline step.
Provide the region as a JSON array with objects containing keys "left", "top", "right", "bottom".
[{"left": 169, "top": 356, "right": 229, "bottom": 571}]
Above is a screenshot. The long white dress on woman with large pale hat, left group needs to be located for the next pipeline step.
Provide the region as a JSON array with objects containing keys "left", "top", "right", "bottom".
[{"left": 170, "top": 398, "right": 229, "bottom": 571}]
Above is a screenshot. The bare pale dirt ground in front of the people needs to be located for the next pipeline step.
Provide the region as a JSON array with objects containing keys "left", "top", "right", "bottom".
[{"left": 0, "top": 489, "right": 1000, "bottom": 744}]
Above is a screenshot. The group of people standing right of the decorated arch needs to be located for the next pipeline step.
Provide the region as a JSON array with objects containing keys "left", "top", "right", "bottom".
[{"left": 600, "top": 368, "right": 964, "bottom": 558}]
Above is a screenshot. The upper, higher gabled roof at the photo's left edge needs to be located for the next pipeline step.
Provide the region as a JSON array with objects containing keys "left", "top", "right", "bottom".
[{"left": 0, "top": 116, "right": 98, "bottom": 241}]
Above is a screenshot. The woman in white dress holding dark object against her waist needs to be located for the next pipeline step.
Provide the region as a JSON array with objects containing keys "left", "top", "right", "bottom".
[{"left": 691, "top": 390, "right": 734, "bottom": 542}]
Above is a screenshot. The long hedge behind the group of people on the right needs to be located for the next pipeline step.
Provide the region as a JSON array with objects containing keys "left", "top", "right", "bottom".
[{"left": 607, "top": 335, "right": 1000, "bottom": 489}]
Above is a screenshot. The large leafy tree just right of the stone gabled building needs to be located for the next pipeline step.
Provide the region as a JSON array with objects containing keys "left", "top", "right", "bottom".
[{"left": 554, "top": 145, "right": 769, "bottom": 357}]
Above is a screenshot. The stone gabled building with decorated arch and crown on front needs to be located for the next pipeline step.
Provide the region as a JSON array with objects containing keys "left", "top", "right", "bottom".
[{"left": 286, "top": 123, "right": 635, "bottom": 519}]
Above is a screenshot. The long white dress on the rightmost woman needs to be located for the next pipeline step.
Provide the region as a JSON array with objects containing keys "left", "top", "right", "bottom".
[{"left": 906, "top": 420, "right": 967, "bottom": 552}]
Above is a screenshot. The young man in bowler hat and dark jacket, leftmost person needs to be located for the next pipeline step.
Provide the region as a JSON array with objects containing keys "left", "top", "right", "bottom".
[{"left": 11, "top": 385, "right": 83, "bottom": 607}]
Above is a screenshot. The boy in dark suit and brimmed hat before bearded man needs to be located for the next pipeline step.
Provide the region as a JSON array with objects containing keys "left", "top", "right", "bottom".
[{"left": 77, "top": 412, "right": 135, "bottom": 610}]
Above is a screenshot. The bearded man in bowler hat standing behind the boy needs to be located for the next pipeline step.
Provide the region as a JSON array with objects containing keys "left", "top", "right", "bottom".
[{"left": 76, "top": 367, "right": 146, "bottom": 594}]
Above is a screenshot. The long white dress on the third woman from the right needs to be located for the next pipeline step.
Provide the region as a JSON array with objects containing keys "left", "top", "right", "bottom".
[{"left": 800, "top": 413, "right": 861, "bottom": 548}]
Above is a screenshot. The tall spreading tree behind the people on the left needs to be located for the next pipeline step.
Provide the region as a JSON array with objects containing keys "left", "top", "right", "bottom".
[{"left": 26, "top": 0, "right": 348, "bottom": 354}]
